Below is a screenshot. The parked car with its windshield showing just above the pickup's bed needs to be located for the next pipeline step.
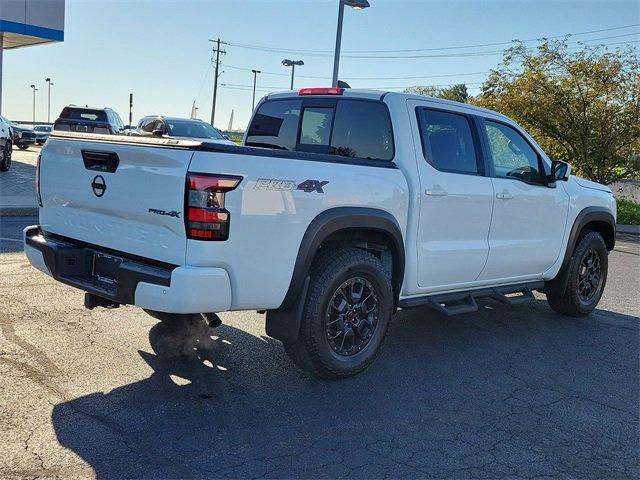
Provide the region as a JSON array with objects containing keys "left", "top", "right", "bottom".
[{"left": 133, "top": 115, "right": 235, "bottom": 145}]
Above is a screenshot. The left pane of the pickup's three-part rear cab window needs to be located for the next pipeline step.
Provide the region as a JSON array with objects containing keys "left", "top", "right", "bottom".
[{"left": 245, "top": 99, "right": 302, "bottom": 151}]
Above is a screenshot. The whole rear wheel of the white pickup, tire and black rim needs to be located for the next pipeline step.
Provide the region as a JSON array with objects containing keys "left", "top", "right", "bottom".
[{"left": 285, "top": 248, "right": 393, "bottom": 378}]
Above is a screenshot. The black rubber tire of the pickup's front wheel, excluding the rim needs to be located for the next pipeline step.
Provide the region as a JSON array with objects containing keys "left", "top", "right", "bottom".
[{"left": 545, "top": 230, "right": 608, "bottom": 317}]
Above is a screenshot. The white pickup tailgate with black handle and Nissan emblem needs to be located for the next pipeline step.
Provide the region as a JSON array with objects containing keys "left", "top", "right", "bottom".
[{"left": 40, "top": 137, "right": 193, "bottom": 265}]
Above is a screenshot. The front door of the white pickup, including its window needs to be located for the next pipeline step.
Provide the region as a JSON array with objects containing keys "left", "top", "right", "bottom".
[{"left": 480, "top": 119, "right": 569, "bottom": 281}]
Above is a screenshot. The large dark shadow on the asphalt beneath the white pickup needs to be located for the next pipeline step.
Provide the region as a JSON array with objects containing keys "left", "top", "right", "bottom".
[{"left": 52, "top": 301, "right": 640, "bottom": 478}]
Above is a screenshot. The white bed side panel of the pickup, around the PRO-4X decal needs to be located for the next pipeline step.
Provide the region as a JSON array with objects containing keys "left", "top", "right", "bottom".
[{"left": 186, "top": 152, "right": 408, "bottom": 310}]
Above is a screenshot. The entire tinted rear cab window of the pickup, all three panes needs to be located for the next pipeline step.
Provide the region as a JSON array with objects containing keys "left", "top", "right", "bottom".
[{"left": 245, "top": 97, "right": 394, "bottom": 161}]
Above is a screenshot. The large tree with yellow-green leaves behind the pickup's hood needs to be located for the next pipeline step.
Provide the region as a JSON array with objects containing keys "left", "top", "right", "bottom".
[{"left": 473, "top": 38, "right": 640, "bottom": 184}]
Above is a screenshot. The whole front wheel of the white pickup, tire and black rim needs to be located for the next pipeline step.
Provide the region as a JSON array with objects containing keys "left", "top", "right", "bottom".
[{"left": 546, "top": 232, "right": 609, "bottom": 317}]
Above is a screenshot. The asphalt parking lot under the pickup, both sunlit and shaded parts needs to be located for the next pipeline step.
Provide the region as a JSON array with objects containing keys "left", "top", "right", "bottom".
[{"left": 0, "top": 218, "right": 640, "bottom": 479}]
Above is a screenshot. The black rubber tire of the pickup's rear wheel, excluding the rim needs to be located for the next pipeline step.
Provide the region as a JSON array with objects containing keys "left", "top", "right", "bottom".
[{"left": 284, "top": 248, "right": 393, "bottom": 378}]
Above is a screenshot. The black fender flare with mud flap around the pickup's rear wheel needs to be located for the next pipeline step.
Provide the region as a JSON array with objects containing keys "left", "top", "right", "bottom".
[{"left": 267, "top": 207, "right": 405, "bottom": 342}]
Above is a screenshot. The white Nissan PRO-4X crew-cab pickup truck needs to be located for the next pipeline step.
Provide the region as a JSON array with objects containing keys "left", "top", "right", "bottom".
[{"left": 24, "top": 88, "right": 616, "bottom": 377}]
